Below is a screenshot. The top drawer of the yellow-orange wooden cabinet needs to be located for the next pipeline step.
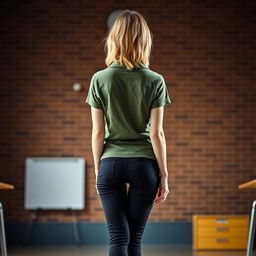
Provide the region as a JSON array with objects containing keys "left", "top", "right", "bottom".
[{"left": 196, "top": 216, "right": 249, "bottom": 226}]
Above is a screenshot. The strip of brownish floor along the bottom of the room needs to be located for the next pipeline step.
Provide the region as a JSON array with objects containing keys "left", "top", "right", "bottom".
[{"left": 8, "top": 245, "right": 246, "bottom": 256}]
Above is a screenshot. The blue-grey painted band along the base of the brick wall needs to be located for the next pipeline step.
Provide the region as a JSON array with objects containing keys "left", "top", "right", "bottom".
[{"left": 5, "top": 221, "right": 192, "bottom": 245}]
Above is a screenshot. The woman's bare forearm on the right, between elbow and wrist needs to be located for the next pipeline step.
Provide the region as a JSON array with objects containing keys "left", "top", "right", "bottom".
[{"left": 150, "top": 132, "right": 168, "bottom": 177}]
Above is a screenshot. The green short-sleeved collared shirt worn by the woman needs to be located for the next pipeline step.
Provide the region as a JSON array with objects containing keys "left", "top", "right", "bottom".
[{"left": 85, "top": 62, "right": 171, "bottom": 160}]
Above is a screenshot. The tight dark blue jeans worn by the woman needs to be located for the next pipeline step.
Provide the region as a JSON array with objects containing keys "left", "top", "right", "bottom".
[{"left": 96, "top": 157, "right": 160, "bottom": 256}]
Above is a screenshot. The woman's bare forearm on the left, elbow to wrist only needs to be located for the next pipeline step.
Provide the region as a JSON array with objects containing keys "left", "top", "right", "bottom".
[{"left": 91, "top": 132, "right": 104, "bottom": 175}]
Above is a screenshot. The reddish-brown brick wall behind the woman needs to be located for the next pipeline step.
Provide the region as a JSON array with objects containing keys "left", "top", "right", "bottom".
[{"left": 0, "top": 0, "right": 256, "bottom": 221}]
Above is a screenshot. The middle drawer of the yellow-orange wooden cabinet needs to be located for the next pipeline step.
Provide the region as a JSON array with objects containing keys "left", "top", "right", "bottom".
[{"left": 196, "top": 226, "right": 248, "bottom": 238}]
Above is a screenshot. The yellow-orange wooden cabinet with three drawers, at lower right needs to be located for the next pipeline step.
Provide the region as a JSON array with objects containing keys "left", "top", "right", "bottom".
[{"left": 192, "top": 215, "right": 249, "bottom": 250}]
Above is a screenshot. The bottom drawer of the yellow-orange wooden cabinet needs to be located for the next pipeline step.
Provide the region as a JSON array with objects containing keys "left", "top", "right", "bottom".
[{"left": 196, "top": 237, "right": 247, "bottom": 249}]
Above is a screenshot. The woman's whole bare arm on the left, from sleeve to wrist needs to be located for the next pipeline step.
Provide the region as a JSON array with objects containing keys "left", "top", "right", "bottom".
[{"left": 91, "top": 107, "right": 105, "bottom": 178}]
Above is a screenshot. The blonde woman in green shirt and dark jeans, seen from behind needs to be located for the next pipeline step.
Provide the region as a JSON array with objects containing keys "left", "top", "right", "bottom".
[{"left": 86, "top": 10, "right": 171, "bottom": 256}]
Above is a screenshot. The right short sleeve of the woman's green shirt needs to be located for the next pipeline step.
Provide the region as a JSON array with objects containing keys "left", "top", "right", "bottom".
[{"left": 151, "top": 75, "right": 171, "bottom": 108}]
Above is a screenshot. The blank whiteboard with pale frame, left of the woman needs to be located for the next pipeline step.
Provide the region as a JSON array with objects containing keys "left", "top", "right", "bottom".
[{"left": 24, "top": 157, "right": 85, "bottom": 209}]
